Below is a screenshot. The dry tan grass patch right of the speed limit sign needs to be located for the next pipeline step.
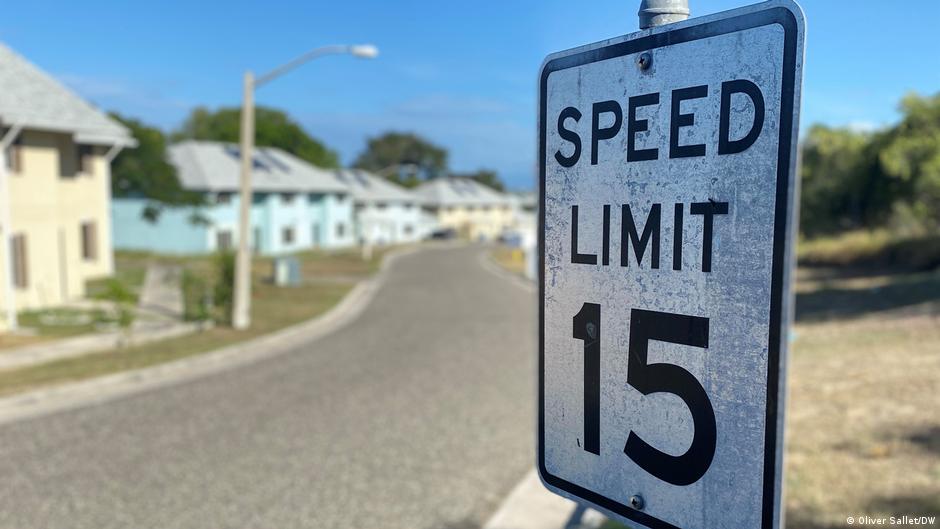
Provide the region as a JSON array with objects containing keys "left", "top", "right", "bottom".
[{"left": 786, "top": 273, "right": 940, "bottom": 529}]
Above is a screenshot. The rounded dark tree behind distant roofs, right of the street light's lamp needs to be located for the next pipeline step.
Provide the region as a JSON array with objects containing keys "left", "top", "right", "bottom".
[{"left": 353, "top": 131, "right": 447, "bottom": 187}]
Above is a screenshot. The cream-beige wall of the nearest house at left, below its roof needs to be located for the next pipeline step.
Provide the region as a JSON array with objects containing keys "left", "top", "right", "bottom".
[{"left": 0, "top": 130, "right": 114, "bottom": 320}]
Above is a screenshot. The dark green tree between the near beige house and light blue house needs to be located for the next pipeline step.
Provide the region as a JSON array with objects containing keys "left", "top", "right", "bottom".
[{"left": 111, "top": 113, "right": 203, "bottom": 220}]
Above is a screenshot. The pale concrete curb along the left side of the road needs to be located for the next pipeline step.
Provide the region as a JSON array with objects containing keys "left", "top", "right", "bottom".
[{"left": 0, "top": 247, "right": 418, "bottom": 425}]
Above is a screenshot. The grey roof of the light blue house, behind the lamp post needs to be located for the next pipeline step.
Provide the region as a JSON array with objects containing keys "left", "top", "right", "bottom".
[{"left": 168, "top": 140, "right": 348, "bottom": 193}]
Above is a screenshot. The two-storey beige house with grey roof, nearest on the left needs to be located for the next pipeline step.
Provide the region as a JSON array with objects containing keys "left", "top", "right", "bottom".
[{"left": 0, "top": 44, "right": 135, "bottom": 329}]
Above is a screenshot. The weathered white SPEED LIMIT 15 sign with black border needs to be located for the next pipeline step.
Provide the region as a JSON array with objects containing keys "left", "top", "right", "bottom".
[{"left": 538, "top": 0, "right": 804, "bottom": 529}]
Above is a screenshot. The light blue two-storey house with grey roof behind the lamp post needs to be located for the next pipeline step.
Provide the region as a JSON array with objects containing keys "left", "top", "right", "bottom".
[{"left": 112, "top": 141, "right": 356, "bottom": 255}]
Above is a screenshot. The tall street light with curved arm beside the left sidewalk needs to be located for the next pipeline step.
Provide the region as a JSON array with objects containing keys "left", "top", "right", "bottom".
[{"left": 232, "top": 44, "right": 379, "bottom": 329}]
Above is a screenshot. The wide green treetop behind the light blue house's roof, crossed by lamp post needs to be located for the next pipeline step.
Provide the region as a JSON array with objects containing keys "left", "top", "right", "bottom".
[{"left": 173, "top": 106, "right": 339, "bottom": 167}]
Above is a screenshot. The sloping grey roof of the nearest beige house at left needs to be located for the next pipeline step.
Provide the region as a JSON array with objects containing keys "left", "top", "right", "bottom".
[{"left": 0, "top": 44, "right": 137, "bottom": 146}]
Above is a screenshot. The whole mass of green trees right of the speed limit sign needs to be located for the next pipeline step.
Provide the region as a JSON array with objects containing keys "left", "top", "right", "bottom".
[{"left": 800, "top": 94, "right": 940, "bottom": 236}]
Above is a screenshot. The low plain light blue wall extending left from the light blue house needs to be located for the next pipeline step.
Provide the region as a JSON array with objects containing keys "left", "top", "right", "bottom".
[{"left": 111, "top": 198, "right": 214, "bottom": 254}]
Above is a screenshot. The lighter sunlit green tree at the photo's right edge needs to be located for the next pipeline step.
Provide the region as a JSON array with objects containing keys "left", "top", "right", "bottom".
[{"left": 878, "top": 93, "right": 940, "bottom": 229}]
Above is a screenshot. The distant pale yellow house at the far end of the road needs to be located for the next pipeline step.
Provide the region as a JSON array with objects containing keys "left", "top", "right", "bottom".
[{"left": 415, "top": 178, "right": 515, "bottom": 241}]
